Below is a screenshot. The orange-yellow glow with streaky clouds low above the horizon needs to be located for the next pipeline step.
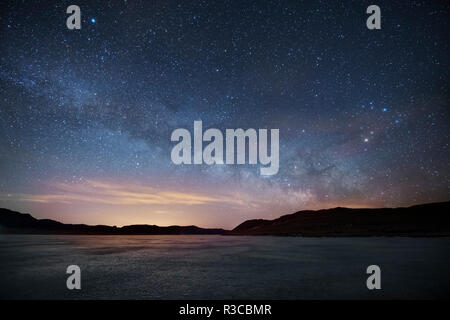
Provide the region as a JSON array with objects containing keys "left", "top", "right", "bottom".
[{"left": 0, "top": 179, "right": 400, "bottom": 229}]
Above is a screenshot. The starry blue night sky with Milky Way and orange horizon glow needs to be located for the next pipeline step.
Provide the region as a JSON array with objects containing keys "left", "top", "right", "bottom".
[{"left": 0, "top": 0, "right": 450, "bottom": 228}]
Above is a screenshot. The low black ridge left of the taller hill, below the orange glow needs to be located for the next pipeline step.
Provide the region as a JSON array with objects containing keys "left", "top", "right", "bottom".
[{"left": 0, "top": 208, "right": 226, "bottom": 235}]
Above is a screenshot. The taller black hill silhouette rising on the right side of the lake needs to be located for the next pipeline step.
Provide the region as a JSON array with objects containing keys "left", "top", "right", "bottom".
[{"left": 227, "top": 202, "right": 450, "bottom": 237}]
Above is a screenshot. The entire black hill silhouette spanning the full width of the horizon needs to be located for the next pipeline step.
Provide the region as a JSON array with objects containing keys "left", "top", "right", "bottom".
[{"left": 0, "top": 202, "right": 450, "bottom": 237}]
